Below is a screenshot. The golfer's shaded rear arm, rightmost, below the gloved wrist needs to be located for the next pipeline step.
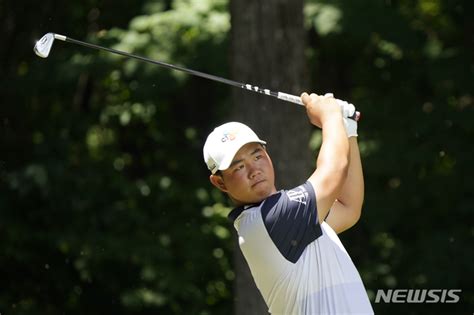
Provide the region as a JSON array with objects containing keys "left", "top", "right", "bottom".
[{"left": 326, "top": 137, "right": 364, "bottom": 233}]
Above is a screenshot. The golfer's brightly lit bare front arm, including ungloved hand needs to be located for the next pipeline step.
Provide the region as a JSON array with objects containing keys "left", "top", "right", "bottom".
[{"left": 302, "top": 93, "right": 349, "bottom": 223}]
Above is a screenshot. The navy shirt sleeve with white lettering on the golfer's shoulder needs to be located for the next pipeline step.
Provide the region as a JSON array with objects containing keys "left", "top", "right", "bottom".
[{"left": 261, "top": 182, "right": 322, "bottom": 263}]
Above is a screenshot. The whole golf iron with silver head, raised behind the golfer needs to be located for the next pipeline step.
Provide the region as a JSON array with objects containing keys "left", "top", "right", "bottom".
[{"left": 34, "top": 33, "right": 360, "bottom": 121}]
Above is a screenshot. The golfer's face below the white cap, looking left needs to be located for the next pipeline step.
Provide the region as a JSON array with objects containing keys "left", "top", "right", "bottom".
[{"left": 211, "top": 143, "right": 276, "bottom": 205}]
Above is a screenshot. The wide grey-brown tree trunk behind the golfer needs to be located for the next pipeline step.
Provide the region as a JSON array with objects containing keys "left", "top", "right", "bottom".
[{"left": 230, "top": 0, "right": 314, "bottom": 315}]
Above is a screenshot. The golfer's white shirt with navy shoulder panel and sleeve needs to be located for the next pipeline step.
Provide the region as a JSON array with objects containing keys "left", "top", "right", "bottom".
[{"left": 229, "top": 182, "right": 373, "bottom": 315}]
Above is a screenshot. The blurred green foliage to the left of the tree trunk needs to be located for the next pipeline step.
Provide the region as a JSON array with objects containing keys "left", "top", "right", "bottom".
[{"left": 0, "top": 1, "right": 234, "bottom": 314}]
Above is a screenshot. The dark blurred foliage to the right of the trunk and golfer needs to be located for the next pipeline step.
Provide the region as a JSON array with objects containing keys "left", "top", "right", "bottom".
[{"left": 306, "top": 0, "right": 474, "bottom": 314}]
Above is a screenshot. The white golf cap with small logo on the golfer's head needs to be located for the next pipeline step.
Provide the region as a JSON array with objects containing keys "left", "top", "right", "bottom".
[{"left": 203, "top": 122, "right": 266, "bottom": 174}]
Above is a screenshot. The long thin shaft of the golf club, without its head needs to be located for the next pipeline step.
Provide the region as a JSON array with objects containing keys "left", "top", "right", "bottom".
[{"left": 54, "top": 34, "right": 360, "bottom": 121}]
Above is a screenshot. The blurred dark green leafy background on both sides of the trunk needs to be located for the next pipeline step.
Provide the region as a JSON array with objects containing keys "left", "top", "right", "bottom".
[{"left": 0, "top": 0, "right": 474, "bottom": 315}]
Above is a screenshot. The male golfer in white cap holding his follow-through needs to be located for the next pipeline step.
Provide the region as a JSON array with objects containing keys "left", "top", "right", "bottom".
[{"left": 204, "top": 93, "right": 373, "bottom": 315}]
